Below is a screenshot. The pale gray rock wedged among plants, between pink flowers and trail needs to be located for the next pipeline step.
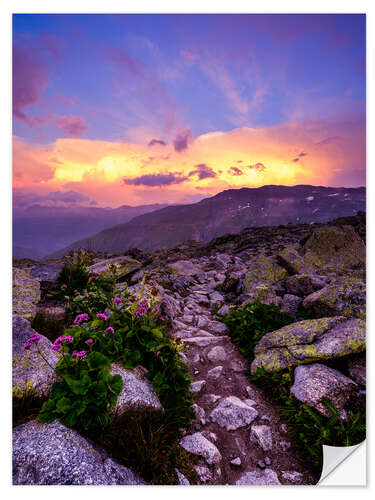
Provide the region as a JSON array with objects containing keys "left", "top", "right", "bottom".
[{"left": 110, "top": 363, "right": 163, "bottom": 415}]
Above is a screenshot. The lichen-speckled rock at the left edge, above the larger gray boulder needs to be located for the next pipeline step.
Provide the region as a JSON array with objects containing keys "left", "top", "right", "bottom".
[{"left": 13, "top": 267, "right": 40, "bottom": 319}]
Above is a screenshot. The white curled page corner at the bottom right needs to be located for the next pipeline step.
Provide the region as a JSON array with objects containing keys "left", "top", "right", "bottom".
[{"left": 318, "top": 441, "right": 366, "bottom": 486}]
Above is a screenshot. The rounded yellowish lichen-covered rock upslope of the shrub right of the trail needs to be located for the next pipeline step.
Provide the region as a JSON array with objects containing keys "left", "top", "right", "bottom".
[{"left": 243, "top": 255, "right": 287, "bottom": 294}]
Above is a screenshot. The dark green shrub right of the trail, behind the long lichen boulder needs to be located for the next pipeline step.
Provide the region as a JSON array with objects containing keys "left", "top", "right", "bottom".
[{"left": 223, "top": 302, "right": 294, "bottom": 363}]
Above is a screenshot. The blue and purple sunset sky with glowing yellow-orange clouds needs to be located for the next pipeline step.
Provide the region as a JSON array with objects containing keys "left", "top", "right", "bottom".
[{"left": 13, "top": 14, "right": 366, "bottom": 207}]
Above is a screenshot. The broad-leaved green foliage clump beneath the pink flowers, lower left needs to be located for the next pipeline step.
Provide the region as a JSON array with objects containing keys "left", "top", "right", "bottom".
[{"left": 39, "top": 351, "right": 122, "bottom": 429}]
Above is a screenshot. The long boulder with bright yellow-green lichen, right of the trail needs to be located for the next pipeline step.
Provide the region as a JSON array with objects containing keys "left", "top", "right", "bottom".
[{"left": 251, "top": 316, "right": 366, "bottom": 373}]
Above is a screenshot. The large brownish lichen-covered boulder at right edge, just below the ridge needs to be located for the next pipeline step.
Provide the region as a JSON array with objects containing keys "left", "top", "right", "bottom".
[{"left": 302, "top": 226, "right": 366, "bottom": 271}]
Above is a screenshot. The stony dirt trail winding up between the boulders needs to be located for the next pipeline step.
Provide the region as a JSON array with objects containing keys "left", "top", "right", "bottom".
[{"left": 172, "top": 264, "right": 318, "bottom": 485}]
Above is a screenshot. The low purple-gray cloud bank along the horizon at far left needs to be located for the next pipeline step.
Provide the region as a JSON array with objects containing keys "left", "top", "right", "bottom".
[{"left": 13, "top": 190, "right": 93, "bottom": 208}]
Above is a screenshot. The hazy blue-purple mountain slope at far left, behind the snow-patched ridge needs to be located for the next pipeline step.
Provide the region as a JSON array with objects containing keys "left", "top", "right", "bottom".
[{"left": 13, "top": 204, "right": 166, "bottom": 258}]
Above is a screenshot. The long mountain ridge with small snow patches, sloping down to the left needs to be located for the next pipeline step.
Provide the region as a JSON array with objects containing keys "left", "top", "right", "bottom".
[{"left": 50, "top": 185, "right": 366, "bottom": 258}]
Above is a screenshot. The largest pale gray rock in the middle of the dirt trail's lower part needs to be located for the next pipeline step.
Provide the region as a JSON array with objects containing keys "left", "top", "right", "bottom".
[{"left": 210, "top": 396, "right": 258, "bottom": 431}]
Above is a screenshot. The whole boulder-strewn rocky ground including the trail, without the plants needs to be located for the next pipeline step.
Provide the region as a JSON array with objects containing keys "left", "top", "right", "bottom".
[{"left": 13, "top": 213, "right": 366, "bottom": 485}]
